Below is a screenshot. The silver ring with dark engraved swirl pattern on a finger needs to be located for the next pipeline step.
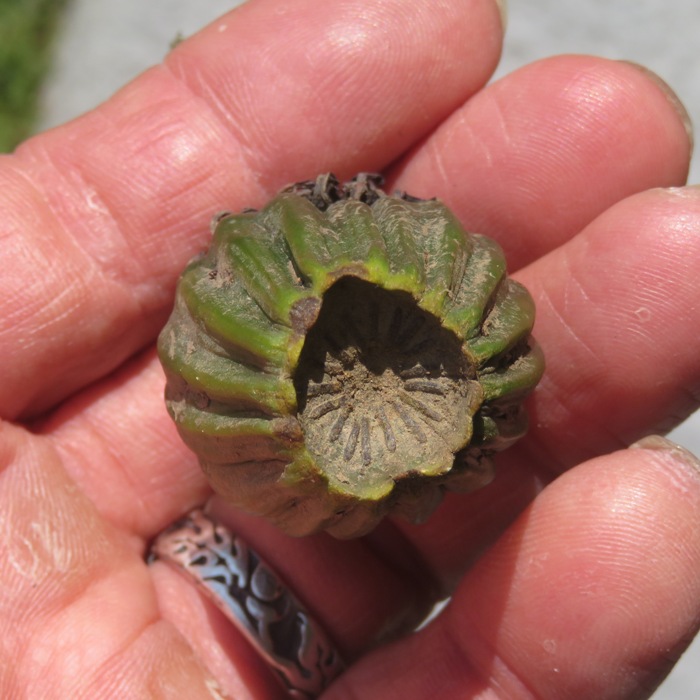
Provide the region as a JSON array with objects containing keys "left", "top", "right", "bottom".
[{"left": 149, "top": 509, "right": 344, "bottom": 700}]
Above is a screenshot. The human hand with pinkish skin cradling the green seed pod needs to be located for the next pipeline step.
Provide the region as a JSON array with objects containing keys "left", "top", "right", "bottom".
[{"left": 0, "top": 0, "right": 700, "bottom": 700}]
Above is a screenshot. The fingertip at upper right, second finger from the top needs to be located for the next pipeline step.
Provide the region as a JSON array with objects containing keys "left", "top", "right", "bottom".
[{"left": 396, "top": 56, "right": 692, "bottom": 269}]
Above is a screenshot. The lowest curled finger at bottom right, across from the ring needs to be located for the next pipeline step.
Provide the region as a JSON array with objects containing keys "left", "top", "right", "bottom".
[{"left": 327, "top": 438, "right": 700, "bottom": 700}]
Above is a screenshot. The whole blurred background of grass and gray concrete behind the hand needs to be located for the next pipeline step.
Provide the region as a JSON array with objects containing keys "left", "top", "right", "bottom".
[{"left": 0, "top": 0, "right": 700, "bottom": 700}]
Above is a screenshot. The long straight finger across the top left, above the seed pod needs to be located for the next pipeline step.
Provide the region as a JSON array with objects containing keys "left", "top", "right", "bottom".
[{"left": 0, "top": 0, "right": 501, "bottom": 418}]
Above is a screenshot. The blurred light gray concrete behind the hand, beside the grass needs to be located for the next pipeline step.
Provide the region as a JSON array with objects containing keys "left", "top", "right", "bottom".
[{"left": 37, "top": 0, "right": 700, "bottom": 700}]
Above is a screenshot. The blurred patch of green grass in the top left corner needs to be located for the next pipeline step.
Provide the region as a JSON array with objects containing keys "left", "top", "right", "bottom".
[{"left": 0, "top": 0, "right": 68, "bottom": 152}]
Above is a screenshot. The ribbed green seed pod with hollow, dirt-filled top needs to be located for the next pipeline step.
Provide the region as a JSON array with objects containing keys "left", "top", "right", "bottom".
[{"left": 159, "top": 175, "right": 543, "bottom": 537}]
